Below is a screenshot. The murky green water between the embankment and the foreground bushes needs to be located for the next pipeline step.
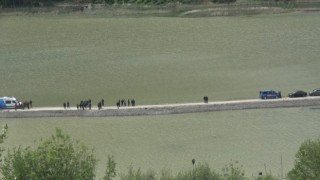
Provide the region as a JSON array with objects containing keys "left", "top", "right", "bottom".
[{"left": 0, "top": 108, "right": 320, "bottom": 178}]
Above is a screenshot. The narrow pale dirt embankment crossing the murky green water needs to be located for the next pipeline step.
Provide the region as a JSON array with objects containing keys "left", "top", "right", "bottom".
[{"left": 0, "top": 97, "right": 320, "bottom": 118}]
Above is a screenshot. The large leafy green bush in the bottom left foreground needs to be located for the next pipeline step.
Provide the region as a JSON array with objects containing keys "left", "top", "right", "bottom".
[{"left": 0, "top": 129, "right": 97, "bottom": 180}]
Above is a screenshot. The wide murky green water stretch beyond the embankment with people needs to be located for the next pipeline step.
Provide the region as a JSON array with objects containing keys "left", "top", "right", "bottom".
[{"left": 0, "top": 13, "right": 320, "bottom": 106}]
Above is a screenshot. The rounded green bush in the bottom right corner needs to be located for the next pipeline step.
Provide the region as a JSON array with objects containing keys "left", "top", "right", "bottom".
[{"left": 288, "top": 138, "right": 320, "bottom": 180}]
